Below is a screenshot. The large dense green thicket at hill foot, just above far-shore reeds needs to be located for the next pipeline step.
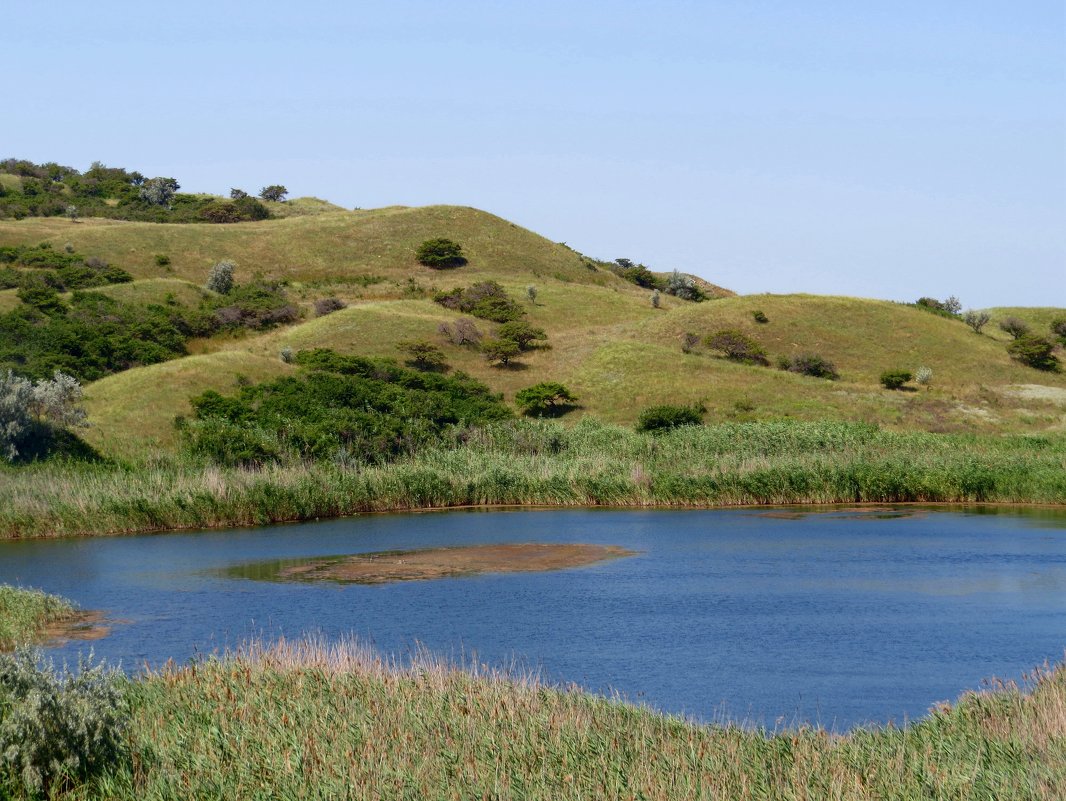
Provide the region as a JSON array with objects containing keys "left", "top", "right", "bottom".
[{"left": 178, "top": 349, "right": 512, "bottom": 466}]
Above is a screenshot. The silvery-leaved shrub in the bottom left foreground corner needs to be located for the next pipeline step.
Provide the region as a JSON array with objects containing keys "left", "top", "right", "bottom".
[{"left": 0, "top": 650, "right": 129, "bottom": 798}]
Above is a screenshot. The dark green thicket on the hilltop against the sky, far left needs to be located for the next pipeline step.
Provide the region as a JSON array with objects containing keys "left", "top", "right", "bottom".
[{"left": 0, "top": 159, "right": 275, "bottom": 223}]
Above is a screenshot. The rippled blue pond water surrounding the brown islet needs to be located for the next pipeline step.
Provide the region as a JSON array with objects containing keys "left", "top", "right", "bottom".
[{"left": 0, "top": 507, "right": 1066, "bottom": 730}]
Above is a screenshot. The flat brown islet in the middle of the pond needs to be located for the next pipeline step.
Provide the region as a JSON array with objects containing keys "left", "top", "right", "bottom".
[{"left": 261, "top": 543, "right": 636, "bottom": 584}]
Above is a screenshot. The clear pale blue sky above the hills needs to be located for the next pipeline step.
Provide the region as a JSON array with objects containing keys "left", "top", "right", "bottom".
[{"left": 8, "top": 0, "right": 1066, "bottom": 307}]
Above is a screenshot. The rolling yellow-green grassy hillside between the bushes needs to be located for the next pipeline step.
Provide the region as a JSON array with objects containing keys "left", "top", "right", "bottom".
[{"left": 0, "top": 198, "right": 1066, "bottom": 455}]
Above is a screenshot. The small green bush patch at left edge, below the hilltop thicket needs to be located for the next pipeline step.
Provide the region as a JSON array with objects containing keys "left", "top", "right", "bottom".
[{"left": 0, "top": 242, "right": 133, "bottom": 292}]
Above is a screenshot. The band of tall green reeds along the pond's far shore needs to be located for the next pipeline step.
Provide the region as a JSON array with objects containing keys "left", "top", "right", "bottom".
[{"left": 0, "top": 419, "right": 1066, "bottom": 538}]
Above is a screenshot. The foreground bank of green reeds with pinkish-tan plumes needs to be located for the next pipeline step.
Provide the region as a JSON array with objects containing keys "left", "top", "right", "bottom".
[{"left": 29, "top": 643, "right": 1066, "bottom": 800}]
